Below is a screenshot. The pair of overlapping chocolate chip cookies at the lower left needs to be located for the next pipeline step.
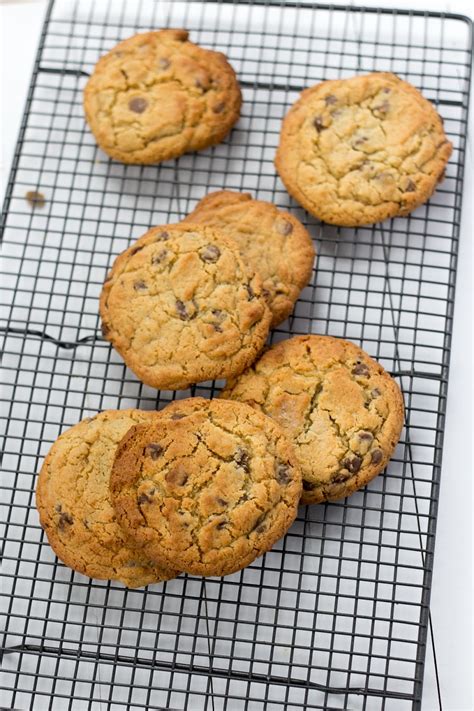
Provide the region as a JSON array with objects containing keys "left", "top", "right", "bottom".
[{"left": 36, "top": 398, "right": 301, "bottom": 587}]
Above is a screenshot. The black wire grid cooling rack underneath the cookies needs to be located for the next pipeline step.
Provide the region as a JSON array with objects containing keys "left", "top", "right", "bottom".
[{"left": 2, "top": 0, "right": 471, "bottom": 711}]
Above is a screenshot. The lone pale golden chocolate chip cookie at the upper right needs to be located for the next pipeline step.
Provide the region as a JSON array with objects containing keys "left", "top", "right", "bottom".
[{"left": 275, "top": 72, "right": 452, "bottom": 226}]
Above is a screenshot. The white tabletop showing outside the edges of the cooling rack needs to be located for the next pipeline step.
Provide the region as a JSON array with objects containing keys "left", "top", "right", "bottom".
[{"left": 0, "top": 0, "right": 474, "bottom": 711}]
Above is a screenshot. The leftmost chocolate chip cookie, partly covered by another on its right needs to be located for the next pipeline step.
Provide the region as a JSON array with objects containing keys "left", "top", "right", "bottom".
[{"left": 36, "top": 410, "right": 179, "bottom": 588}]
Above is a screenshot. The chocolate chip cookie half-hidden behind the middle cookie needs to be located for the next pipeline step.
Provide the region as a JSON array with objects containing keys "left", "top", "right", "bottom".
[{"left": 183, "top": 190, "right": 315, "bottom": 327}]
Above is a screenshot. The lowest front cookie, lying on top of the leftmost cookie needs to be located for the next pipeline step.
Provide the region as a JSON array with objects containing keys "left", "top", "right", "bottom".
[{"left": 110, "top": 398, "right": 301, "bottom": 576}]
